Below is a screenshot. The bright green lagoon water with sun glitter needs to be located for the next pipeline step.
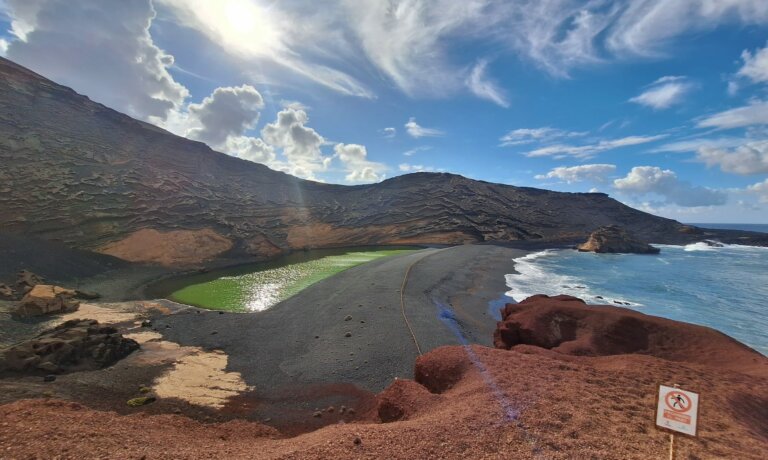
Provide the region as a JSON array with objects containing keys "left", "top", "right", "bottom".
[{"left": 164, "top": 247, "right": 417, "bottom": 312}]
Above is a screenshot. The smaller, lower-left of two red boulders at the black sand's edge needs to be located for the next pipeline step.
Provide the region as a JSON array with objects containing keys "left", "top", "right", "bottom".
[{"left": 376, "top": 379, "right": 440, "bottom": 423}]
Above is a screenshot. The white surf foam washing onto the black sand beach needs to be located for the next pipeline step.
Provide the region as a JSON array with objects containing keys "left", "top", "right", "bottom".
[{"left": 505, "top": 249, "right": 642, "bottom": 307}]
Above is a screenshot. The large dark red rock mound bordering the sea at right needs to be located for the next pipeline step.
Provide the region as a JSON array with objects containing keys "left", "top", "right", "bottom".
[{"left": 493, "top": 295, "right": 768, "bottom": 375}]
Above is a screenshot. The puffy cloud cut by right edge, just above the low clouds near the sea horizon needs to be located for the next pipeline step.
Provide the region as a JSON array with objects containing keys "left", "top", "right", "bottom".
[{"left": 696, "top": 140, "right": 768, "bottom": 175}]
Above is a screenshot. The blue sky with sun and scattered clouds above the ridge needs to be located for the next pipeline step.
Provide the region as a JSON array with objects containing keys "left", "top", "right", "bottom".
[{"left": 0, "top": 0, "right": 768, "bottom": 223}]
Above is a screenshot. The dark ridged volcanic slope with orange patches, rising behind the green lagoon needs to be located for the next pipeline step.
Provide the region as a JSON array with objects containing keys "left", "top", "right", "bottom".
[{"left": 0, "top": 58, "right": 760, "bottom": 265}]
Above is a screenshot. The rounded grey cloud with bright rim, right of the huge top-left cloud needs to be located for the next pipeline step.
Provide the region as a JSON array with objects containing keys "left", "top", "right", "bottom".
[{"left": 187, "top": 85, "right": 264, "bottom": 146}]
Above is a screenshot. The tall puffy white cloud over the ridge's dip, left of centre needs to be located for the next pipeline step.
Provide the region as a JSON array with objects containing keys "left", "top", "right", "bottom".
[{"left": 261, "top": 108, "right": 332, "bottom": 180}]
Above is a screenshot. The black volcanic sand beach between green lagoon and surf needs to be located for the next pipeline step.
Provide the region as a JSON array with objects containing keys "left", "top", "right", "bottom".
[{"left": 154, "top": 245, "right": 527, "bottom": 432}]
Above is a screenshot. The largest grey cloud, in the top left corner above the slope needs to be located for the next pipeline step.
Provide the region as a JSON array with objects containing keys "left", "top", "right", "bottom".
[{"left": 5, "top": 0, "right": 189, "bottom": 120}]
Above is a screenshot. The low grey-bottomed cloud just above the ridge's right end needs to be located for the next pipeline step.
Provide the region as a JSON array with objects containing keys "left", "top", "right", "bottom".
[{"left": 613, "top": 166, "right": 727, "bottom": 207}]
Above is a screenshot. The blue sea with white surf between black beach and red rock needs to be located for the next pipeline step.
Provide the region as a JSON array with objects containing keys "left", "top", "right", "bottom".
[{"left": 506, "top": 243, "right": 768, "bottom": 355}]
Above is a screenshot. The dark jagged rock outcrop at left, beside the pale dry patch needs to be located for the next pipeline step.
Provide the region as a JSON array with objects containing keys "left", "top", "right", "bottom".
[{"left": 0, "top": 320, "right": 139, "bottom": 374}]
